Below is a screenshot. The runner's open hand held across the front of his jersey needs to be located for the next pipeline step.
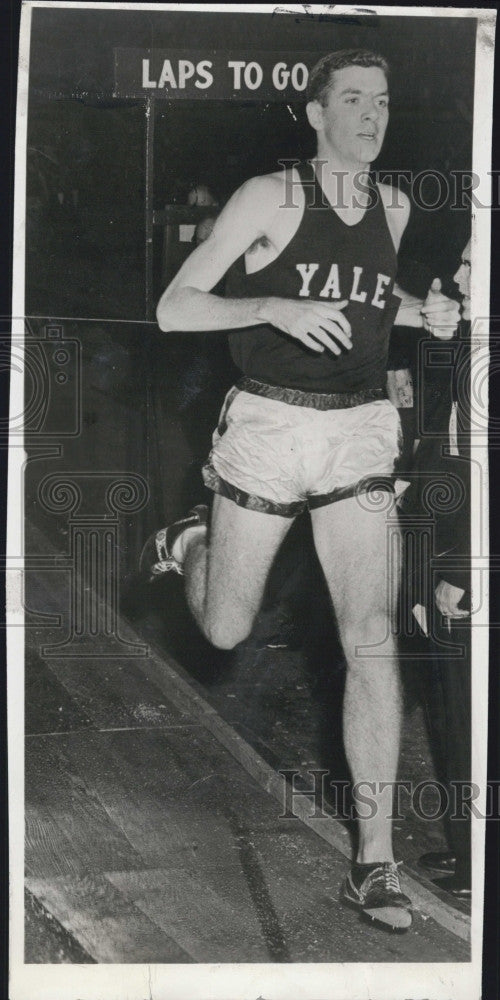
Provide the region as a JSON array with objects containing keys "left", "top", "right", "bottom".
[{"left": 263, "top": 298, "right": 352, "bottom": 354}]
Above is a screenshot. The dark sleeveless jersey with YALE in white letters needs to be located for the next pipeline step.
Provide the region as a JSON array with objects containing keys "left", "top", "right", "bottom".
[{"left": 225, "top": 163, "right": 400, "bottom": 393}]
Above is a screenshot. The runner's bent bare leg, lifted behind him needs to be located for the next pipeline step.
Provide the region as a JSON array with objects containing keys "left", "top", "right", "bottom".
[{"left": 179, "top": 495, "right": 292, "bottom": 649}]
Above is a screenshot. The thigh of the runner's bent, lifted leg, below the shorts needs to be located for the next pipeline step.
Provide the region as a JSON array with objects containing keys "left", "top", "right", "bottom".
[{"left": 207, "top": 494, "right": 293, "bottom": 620}]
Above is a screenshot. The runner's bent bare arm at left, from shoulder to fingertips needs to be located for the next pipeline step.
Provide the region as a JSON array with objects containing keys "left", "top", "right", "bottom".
[{"left": 156, "top": 175, "right": 351, "bottom": 354}]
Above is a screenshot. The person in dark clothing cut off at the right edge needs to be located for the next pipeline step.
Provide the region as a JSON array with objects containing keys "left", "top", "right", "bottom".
[{"left": 402, "top": 245, "right": 471, "bottom": 897}]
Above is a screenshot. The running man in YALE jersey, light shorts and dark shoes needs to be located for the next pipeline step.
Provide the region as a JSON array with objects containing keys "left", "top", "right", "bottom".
[{"left": 142, "top": 50, "right": 459, "bottom": 929}]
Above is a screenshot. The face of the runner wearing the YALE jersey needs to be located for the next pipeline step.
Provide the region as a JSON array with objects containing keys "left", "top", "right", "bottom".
[{"left": 310, "top": 66, "right": 389, "bottom": 167}]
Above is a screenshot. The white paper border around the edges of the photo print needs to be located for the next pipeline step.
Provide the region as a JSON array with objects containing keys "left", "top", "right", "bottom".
[{"left": 7, "top": 0, "right": 496, "bottom": 1000}]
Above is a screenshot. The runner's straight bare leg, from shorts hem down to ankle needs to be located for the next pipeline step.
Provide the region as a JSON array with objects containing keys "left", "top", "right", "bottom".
[{"left": 312, "top": 496, "right": 401, "bottom": 863}]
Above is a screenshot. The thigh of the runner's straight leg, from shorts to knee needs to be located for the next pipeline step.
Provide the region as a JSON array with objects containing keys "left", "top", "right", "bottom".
[{"left": 311, "top": 493, "right": 400, "bottom": 626}]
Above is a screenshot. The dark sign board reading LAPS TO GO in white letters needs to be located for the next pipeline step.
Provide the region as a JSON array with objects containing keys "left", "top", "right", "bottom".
[{"left": 114, "top": 48, "right": 322, "bottom": 101}]
